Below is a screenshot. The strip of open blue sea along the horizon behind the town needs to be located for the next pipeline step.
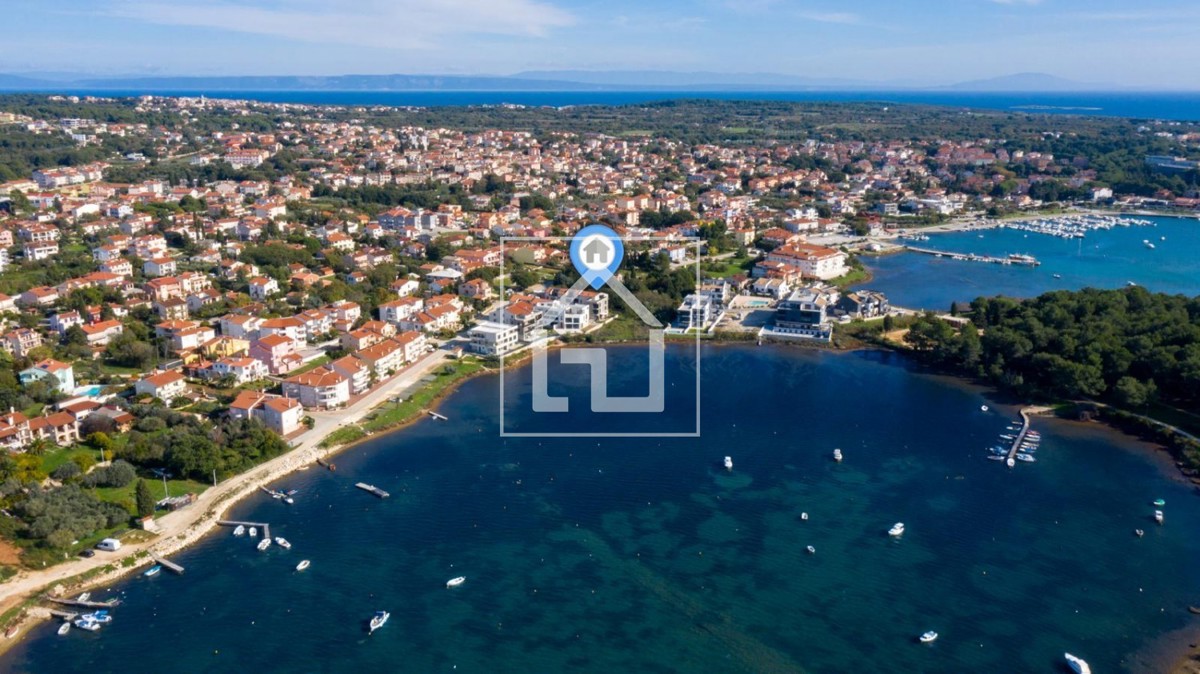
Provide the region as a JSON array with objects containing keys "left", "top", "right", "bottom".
[{"left": 14, "top": 89, "right": 1200, "bottom": 120}]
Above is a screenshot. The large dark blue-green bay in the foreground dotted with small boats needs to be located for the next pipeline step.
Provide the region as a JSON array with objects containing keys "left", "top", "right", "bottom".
[{"left": 0, "top": 347, "right": 1200, "bottom": 673}]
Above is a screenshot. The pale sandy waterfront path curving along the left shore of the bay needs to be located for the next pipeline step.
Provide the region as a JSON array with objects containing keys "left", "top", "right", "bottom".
[{"left": 0, "top": 349, "right": 450, "bottom": 643}]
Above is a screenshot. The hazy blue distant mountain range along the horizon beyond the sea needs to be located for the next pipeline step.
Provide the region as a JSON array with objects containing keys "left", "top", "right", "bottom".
[{"left": 0, "top": 71, "right": 1121, "bottom": 92}]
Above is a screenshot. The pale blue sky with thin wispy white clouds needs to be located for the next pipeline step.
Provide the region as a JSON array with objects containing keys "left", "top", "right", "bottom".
[{"left": 0, "top": 0, "right": 1200, "bottom": 90}]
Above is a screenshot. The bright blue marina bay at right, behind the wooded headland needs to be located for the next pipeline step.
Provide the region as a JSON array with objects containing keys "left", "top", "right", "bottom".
[{"left": 864, "top": 217, "right": 1200, "bottom": 309}]
